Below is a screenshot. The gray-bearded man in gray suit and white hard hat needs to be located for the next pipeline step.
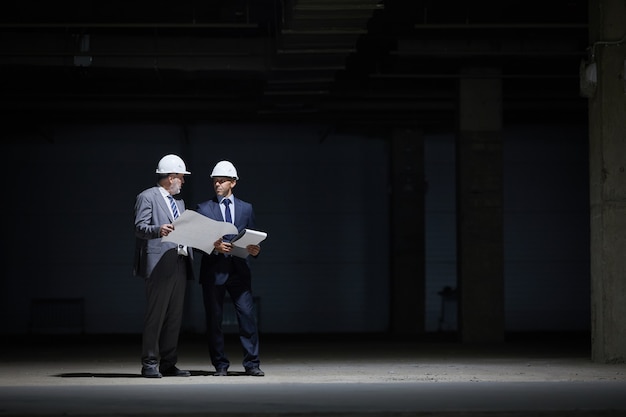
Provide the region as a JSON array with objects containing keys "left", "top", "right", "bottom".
[{"left": 133, "top": 154, "right": 193, "bottom": 378}]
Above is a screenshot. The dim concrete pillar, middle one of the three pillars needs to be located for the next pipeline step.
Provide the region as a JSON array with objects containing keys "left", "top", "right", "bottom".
[{"left": 456, "top": 68, "right": 504, "bottom": 343}]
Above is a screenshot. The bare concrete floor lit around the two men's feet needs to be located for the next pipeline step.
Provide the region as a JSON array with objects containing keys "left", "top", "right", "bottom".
[{"left": 0, "top": 335, "right": 626, "bottom": 417}]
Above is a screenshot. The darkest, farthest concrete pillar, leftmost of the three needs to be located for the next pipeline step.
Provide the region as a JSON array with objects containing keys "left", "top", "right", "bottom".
[{"left": 389, "top": 128, "right": 426, "bottom": 335}]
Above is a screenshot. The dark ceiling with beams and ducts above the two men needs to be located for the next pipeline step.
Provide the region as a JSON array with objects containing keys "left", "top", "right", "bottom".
[{"left": 0, "top": 0, "right": 588, "bottom": 126}]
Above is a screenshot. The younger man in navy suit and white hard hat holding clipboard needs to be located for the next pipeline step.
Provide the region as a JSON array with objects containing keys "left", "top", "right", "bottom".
[{"left": 197, "top": 161, "right": 265, "bottom": 376}]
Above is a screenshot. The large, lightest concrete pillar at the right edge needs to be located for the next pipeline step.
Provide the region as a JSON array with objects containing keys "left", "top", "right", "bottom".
[{"left": 586, "top": 0, "right": 626, "bottom": 363}]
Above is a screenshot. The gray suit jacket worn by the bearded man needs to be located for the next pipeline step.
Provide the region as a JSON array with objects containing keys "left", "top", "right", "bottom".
[{"left": 133, "top": 186, "right": 193, "bottom": 279}]
